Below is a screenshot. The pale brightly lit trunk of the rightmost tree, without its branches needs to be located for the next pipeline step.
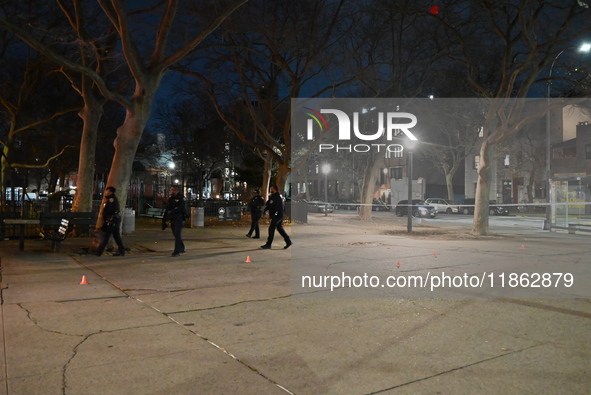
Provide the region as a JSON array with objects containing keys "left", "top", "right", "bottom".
[{"left": 470, "top": 140, "right": 493, "bottom": 236}]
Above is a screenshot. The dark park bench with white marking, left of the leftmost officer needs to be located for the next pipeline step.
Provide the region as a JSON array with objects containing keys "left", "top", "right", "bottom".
[{"left": 40, "top": 212, "right": 98, "bottom": 252}]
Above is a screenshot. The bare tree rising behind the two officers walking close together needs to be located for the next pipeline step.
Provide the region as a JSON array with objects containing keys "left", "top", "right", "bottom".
[{"left": 182, "top": 0, "right": 351, "bottom": 196}]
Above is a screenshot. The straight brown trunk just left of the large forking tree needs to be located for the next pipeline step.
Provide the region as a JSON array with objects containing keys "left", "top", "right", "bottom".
[{"left": 72, "top": 100, "right": 103, "bottom": 212}]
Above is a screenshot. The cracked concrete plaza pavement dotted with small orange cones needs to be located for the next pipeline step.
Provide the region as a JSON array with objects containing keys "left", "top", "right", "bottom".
[{"left": 0, "top": 216, "right": 591, "bottom": 394}]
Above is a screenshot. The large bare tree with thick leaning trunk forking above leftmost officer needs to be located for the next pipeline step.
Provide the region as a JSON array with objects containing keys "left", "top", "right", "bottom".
[{"left": 0, "top": 0, "right": 247, "bottom": 226}]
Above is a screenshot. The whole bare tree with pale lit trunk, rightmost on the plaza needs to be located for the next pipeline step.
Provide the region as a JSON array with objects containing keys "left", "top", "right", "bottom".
[{"left": 432, "top": 0, "right": 591, "bottom": 235}]
